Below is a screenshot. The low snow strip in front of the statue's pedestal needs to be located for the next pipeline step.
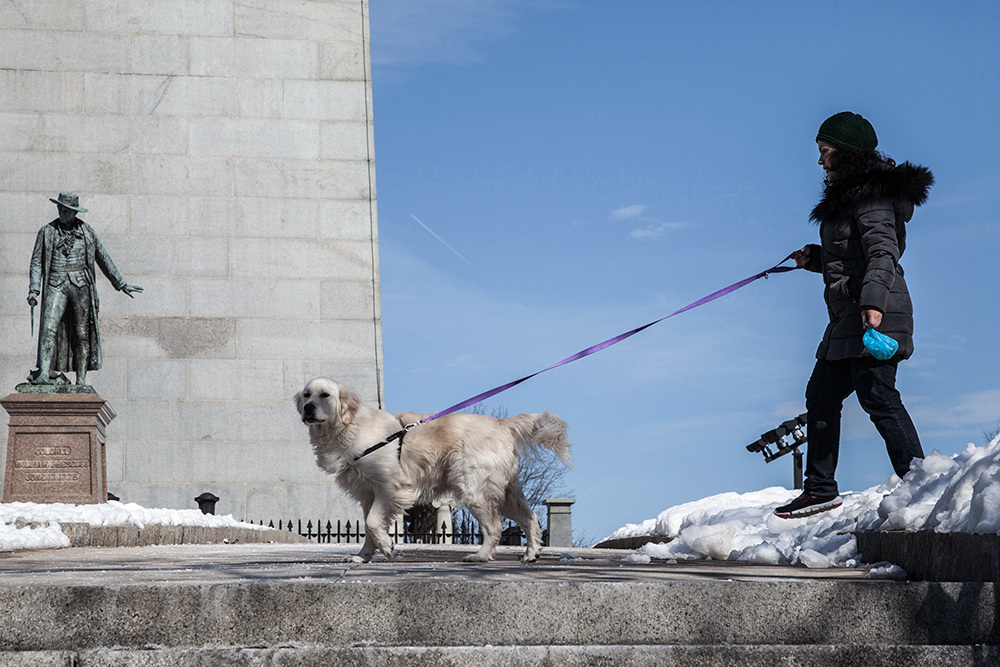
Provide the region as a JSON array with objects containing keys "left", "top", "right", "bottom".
[{"left": 0, "top": 500, "right": 268, "bottom": 551}]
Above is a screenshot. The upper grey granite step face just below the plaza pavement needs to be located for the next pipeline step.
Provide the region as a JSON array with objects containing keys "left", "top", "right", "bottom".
[{"left": 0, "top": 577, "right": 998, "bottom": 650}]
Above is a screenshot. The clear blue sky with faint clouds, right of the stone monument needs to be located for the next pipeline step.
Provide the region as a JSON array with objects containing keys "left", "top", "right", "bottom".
[{"left": 370, "top": 0, "right": 1000, "bottom": 540}]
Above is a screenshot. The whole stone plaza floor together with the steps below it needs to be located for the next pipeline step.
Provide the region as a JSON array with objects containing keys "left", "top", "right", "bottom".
[{"left": 0, "top": 544, "right": 1000, "bottom": 667}]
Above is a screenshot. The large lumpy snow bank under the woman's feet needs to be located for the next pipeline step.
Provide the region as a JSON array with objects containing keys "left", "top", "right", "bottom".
[{"left": 609, "top": 437, "right": 1000, "bottom": 576}]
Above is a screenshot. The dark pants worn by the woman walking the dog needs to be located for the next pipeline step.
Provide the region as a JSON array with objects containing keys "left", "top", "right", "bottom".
[{"left": 805, "top": 357, "right": 924, "bottom": 495}]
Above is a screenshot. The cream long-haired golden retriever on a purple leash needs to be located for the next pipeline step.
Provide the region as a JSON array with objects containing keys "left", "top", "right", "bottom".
[{"left": 294, "top": 377, "right": 572, "bottom": 563}]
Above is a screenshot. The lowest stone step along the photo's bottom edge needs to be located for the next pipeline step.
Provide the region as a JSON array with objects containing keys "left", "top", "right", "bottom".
[{"left": 0, "top": 644, "right": 1000, "bottom": 667}]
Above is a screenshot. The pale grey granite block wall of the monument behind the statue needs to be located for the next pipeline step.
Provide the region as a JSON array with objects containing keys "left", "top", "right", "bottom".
[{"left": 0, "top": 0, "right": 383, "bottom": 519}]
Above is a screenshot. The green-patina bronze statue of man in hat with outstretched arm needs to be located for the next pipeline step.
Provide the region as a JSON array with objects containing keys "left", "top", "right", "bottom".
[{"left": 28, "top": 192, "right": 142, "bottom": 385}]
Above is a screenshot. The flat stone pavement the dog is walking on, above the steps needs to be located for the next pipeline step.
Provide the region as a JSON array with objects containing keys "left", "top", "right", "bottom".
[{"left": 0, "top": 543, "right": 868, "bottom": 589}]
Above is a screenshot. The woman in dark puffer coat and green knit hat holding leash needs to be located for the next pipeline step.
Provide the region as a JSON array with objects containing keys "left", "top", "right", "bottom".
[{"left": 774, "top": 111, "right": 934, "bottom": 518}]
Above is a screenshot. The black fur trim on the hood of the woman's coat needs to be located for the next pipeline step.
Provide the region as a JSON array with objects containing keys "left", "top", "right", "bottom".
[{"left": 809, "top": 162, "right": 934, "bottom": 222}]
